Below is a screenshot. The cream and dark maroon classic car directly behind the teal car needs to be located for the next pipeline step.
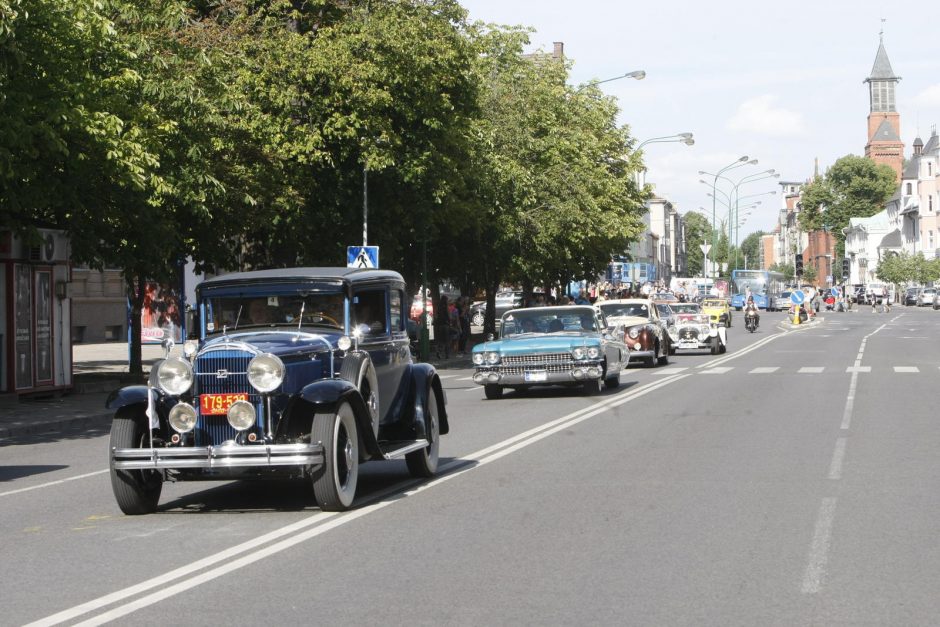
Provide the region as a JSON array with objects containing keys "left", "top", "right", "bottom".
[{"left": 599, "top": 298, "right": 675, "bottom": 368}]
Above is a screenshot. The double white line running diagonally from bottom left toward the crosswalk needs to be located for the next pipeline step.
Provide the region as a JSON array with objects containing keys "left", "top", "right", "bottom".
[{"left": 27, "top": 374, "right": 691, "bottom": 627}]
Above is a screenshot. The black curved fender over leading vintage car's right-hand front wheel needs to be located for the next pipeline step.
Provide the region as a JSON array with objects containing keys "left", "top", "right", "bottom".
[{"left": 286, "top": 379, "right": 382, "bottom": 457}]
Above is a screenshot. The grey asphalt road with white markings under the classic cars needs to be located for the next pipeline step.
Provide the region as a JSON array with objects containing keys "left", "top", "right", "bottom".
[{"left": 0, "top": 308, "right": 940, "bottom": 625}]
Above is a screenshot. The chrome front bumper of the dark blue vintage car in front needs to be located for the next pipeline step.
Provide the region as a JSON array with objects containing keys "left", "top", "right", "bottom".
[{"left": 111, "top": 443, "right": 324, "bottom": 470}]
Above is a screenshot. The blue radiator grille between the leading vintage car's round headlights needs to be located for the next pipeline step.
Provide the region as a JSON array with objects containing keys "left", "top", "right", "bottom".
[{"left": 193, "top": 349, "right": 262, "bottom": 446}]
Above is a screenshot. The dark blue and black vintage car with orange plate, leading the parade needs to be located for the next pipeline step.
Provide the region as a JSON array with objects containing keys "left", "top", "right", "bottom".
[{"left": 108, "top": 268, "right": 448, "bottom": 514}]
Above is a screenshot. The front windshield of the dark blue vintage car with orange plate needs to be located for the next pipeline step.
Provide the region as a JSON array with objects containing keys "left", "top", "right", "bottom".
[{"left": 203, "top": 293, "right": 345, "bottom": 335}]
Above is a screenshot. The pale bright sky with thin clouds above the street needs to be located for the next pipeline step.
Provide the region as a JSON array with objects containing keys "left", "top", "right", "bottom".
[{"left": 461, "top": 0, "right": 940, "bottom": 239}]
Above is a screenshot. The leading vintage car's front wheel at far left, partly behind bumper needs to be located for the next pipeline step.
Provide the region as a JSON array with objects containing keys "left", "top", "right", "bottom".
[{"left": 111, "top": 411, "right": 163, "bottom": 515}]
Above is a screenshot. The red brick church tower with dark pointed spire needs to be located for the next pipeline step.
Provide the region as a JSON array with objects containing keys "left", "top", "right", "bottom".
[{"left": 865, "top": 34, "right": 904, "bottom": 183}]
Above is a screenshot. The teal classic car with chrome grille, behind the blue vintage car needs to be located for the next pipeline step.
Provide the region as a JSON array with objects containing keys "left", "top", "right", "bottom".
[{"left": 473, "top": 306, "right": 630, "bottom": 399}]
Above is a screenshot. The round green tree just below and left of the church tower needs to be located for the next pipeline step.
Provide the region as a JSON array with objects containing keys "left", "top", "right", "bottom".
[{"left": 799, "top": 155, "right": 897, "bottom": 259}]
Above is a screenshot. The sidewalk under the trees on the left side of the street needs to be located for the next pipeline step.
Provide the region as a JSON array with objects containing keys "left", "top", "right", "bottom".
[{"left": 0, "top": 342, "right": 470, "bottom": 447}]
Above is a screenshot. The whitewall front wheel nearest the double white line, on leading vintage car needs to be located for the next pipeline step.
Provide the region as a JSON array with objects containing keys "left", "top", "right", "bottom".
[{"left": 311, "top": 401, "right": 359, "bottom": 512}]
